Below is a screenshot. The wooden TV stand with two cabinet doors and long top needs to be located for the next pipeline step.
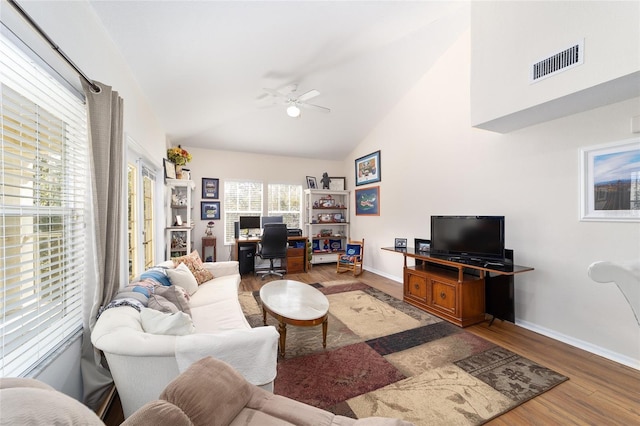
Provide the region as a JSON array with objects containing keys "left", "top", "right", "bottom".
[{"left": 383, "top": 247, "right": 533, "bottom": 327}]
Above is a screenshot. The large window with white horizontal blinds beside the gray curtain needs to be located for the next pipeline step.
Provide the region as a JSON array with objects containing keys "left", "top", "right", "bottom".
[{"left": 0, "top": 37, "right": 89, "bottom": 376}]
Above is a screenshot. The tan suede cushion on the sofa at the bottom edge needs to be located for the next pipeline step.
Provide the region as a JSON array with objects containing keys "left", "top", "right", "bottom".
[{"left": 160, "top": 357, "right": 254, "bottom": 426}]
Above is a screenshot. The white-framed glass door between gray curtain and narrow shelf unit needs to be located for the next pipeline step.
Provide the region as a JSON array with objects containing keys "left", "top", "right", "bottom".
[{"left": 127, "top": 159, "right": 155, "bottom": 279}]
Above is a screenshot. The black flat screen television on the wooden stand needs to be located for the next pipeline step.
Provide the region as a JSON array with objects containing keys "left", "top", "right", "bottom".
[{"left": 430, "top": 216, "right": 504, "bottom": 260}]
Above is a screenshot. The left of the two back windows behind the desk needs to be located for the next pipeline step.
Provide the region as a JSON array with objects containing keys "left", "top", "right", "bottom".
[{"left": 224, "top": 180, "right": 263, "bottom": 244}]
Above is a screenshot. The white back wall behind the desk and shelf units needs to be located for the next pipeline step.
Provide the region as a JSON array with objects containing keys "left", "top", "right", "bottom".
[{"left": 175, "top": 146, "right": 344, "bottom": 260}]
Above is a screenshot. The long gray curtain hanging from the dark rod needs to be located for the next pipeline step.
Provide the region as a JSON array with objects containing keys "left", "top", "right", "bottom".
[{"left": 80, "top": 81, "right": 124, "bottom": 410}]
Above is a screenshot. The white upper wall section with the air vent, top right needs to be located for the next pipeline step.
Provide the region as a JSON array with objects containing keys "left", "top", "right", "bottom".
[{"left": 471, "top": 1, "right": 640, "bottom": 130}]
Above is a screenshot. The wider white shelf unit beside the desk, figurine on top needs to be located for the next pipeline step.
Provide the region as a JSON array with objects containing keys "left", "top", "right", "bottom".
[{"left": 304, "top": 189, "right": 350, "bottom": 264}]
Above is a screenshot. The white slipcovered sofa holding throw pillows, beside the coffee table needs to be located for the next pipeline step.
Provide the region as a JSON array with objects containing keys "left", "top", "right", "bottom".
[{"left": 91, "top": 261, "right": 279, "bottom": 417}]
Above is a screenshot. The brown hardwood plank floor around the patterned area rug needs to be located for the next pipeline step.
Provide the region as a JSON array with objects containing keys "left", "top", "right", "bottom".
[{"left": 106, "top": 264, "right": 640, "bottom": 426}]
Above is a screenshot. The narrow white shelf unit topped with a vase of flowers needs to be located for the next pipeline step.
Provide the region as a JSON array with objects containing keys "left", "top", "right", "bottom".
[{"left": 165, "top": 179, "right": 196, "bottom": 259}]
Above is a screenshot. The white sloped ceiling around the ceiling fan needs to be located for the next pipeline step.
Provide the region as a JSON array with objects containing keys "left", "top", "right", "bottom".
[{"left": 90, "top": 0, "right": 469, "bottom": 160}]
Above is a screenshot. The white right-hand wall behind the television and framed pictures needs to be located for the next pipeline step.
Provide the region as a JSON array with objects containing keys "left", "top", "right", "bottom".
[{"left": 345, "top": 28, "right": 640, "bottom": 368}]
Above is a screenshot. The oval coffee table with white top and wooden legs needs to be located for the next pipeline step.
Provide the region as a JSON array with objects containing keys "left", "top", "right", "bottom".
[{"left": 260, "top": 280, "right": 329, "bottom": 357}]
